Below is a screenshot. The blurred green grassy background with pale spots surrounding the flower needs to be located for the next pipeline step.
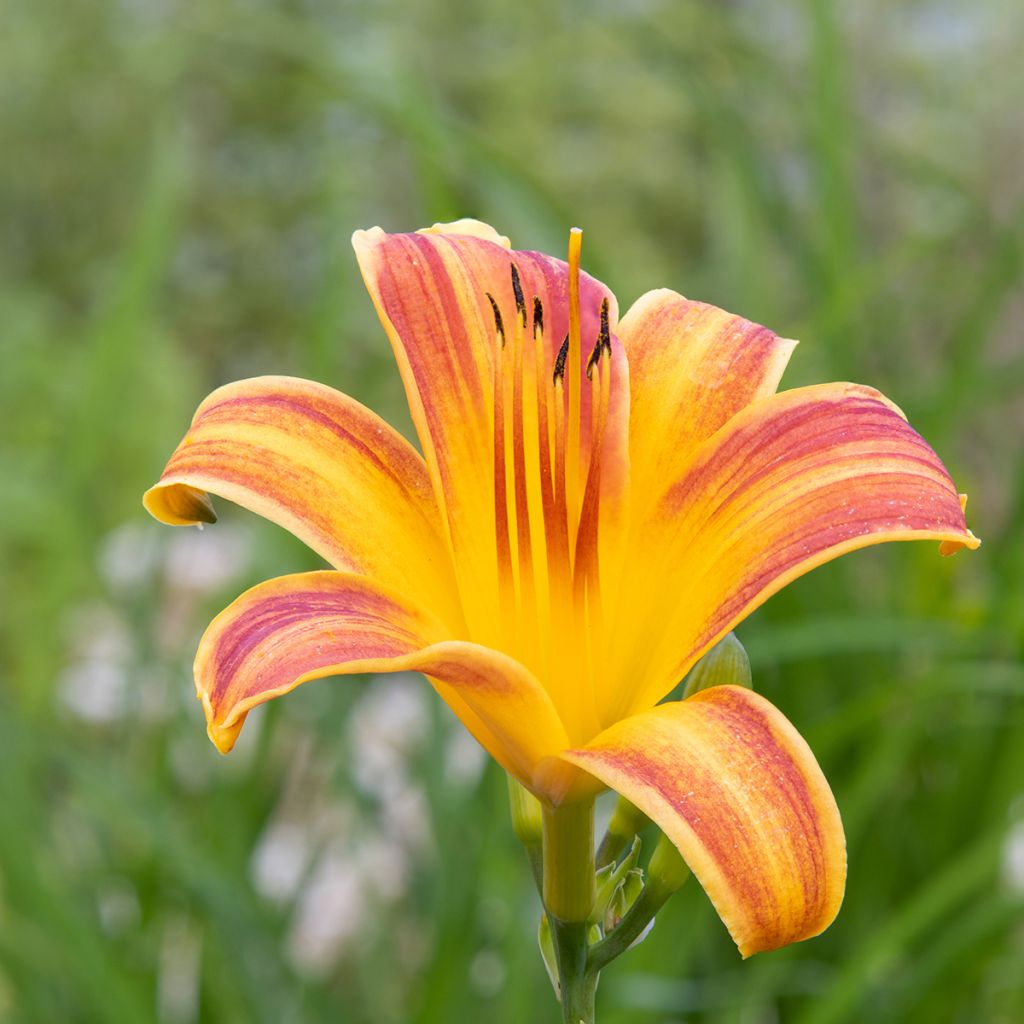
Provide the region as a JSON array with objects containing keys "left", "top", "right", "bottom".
[{"left": 0, "top": 0, "right": 1024, "bottom": 1024}]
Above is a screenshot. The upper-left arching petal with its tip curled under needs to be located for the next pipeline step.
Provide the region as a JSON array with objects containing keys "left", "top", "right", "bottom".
[{"left": 143, "top": 377, "right": 460, "bottom": 624}]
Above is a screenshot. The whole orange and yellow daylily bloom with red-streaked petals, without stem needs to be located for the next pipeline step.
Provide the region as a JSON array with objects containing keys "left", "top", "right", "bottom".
[{"left": 144, "top": 220, "right": 979, "bottom": 955}]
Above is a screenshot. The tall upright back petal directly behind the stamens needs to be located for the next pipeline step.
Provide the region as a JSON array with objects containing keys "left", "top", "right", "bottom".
[{"left": 352, "top": 221, "right": 629, "bottom": 641}]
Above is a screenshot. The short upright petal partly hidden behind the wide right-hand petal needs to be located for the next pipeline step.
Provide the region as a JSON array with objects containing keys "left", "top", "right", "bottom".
[{"left": 618, "top": 289, "right": 797, "bottom": 496}]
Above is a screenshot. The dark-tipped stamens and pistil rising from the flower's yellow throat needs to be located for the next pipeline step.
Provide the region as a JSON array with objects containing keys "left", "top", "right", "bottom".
[{"left": 487, "top": 227, "right": 611, "bottom": 704}]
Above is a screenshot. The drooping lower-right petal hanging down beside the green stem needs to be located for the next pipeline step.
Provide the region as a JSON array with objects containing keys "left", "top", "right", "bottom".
[{"left": 562, "top": 686, "right": 846, "bottom": 957}]
